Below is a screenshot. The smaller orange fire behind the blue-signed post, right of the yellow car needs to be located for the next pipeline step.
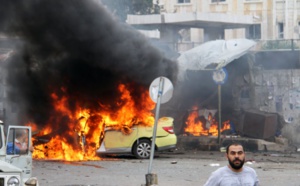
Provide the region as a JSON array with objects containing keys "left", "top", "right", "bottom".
[{"left": 184, "top": 106, "right": 230, "bottom": 136}]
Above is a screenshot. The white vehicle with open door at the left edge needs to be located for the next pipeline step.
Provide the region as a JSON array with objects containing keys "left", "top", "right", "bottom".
[{"left": 0, "top": 121, "right": 38, "bottom": 186}]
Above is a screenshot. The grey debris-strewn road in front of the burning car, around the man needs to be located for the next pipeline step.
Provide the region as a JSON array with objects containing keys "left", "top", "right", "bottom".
[{"left": 33, "top": 151, "right": 300, "bottom": 186}]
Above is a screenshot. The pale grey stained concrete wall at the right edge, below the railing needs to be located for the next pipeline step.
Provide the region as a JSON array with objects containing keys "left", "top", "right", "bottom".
[{"left": 254, "top": 69, "right": 300, "bottom": 144}]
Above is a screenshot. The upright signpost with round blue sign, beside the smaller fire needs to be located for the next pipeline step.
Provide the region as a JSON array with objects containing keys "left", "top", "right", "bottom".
[{"left": 213, "top": 68, "right": 228, "bottom": 145}]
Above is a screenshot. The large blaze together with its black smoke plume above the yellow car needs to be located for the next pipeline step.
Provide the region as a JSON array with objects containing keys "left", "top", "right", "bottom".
[{"left": 0, "top": 0, "right": 177, "bottom": 160}]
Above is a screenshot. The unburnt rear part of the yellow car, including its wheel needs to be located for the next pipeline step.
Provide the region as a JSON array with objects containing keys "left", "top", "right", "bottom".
[{"left": 97, "top": 117, "right": 177, "bottom": 159}]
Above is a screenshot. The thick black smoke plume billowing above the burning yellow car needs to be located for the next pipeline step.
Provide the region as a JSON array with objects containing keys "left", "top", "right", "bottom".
[{"left": 0, "top": 0, "right": 177, "bottom": 125}]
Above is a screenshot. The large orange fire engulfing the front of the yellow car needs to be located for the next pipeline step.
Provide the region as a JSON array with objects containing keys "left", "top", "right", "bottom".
[{"left": 29, "top": 84, "right": 155, "bottom": 161}]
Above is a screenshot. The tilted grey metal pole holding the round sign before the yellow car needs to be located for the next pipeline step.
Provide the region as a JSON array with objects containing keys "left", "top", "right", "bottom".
[{"left": 148, "top": 77, "right": 164, "bottom": 174}]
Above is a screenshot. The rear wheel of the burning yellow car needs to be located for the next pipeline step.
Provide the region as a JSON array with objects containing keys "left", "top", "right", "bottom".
[{"left": 133, "top": 139, "right": 151, "bottom": 159}]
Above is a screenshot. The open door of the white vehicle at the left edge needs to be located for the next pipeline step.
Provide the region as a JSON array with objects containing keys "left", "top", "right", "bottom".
[{"left": 5, "top": 126, "right": 32, "bottom": 179}]
